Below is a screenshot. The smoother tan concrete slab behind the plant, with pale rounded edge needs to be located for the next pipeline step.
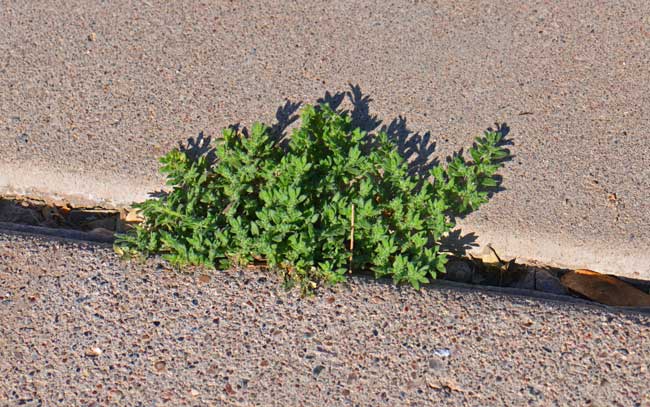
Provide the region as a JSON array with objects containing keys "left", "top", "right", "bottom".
[{"left": 0, "top": 0, "right": 650, "bottom": 278}]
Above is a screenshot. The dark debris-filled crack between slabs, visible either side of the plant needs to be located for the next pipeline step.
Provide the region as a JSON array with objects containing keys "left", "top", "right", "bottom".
[{"left": 0, "top": 197, "right": 650, "bottom": 306}]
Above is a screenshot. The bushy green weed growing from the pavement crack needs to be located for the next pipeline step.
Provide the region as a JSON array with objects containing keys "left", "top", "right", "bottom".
[{"left": 116, "top": 104, "right": 507, "bottom": 291}]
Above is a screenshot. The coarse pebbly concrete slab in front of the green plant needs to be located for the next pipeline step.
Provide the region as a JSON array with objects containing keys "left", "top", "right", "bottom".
[{"left": 0, "top": 234, "right": 650, "bottom": 406}]
